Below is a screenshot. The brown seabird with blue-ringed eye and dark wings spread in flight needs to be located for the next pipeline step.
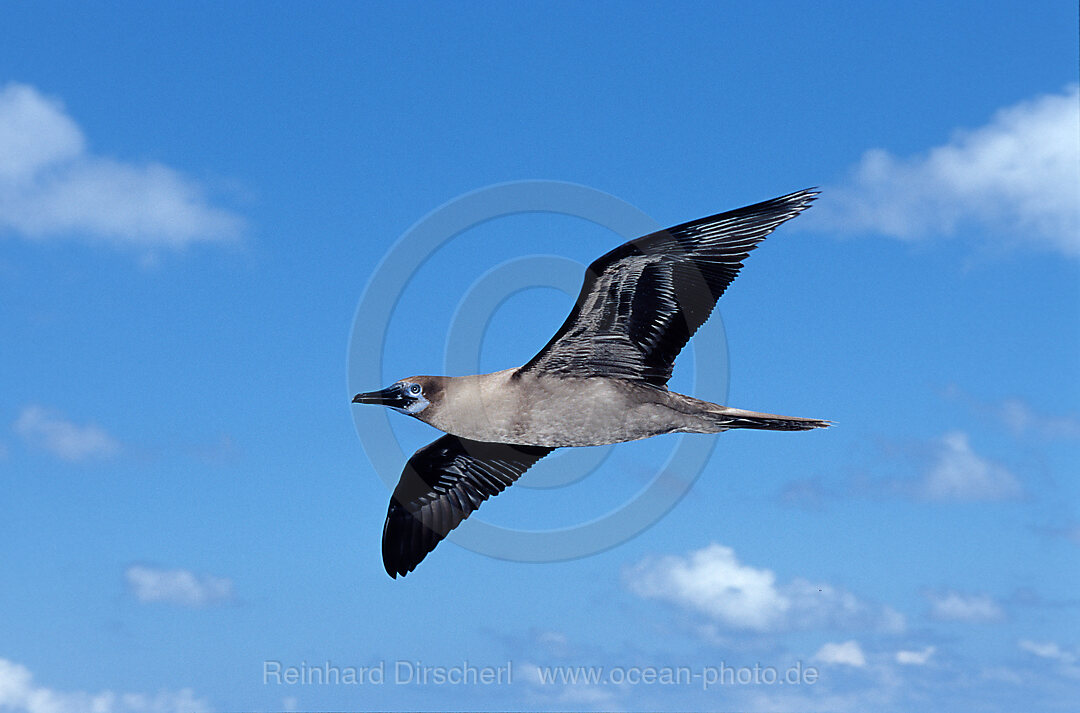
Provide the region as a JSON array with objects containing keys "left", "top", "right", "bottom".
[{"left": 352, "top": 188, "right": 832, "bottom": 578}]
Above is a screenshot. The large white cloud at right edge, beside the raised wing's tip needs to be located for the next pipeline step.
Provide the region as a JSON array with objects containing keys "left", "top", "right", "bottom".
[{"left": 810, "top": 85, "right": 1080, "bottom": 257}]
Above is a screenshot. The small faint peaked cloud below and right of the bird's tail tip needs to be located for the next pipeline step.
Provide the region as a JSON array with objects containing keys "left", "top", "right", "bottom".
[{"left": 920, "top": 431, "right": 1023, "bottom": 500}]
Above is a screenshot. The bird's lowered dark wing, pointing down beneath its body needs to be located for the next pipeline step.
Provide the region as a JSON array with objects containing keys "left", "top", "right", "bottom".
[{"left": 382, "top": 435, "right": 554, "bottom": 577}]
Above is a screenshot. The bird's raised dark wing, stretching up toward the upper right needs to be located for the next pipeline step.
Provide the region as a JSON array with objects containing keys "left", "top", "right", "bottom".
[{"left": 517, "top": 189, "right": 818, "bottom": 387}]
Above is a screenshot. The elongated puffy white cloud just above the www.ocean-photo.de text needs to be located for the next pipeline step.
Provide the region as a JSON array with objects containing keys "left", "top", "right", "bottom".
[{"left": 625, "top": 543, "right": 904, "bottom": 632}]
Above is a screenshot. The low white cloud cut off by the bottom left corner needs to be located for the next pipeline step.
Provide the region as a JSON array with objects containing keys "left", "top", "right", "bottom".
[{"left": 0, "top": 658, "right": 210, "bottom": 713}]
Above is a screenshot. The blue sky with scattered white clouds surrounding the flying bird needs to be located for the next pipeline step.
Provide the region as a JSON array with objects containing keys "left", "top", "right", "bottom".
[{"left": 0, "top": 2, "right": 1080, "bottom": 713}]
